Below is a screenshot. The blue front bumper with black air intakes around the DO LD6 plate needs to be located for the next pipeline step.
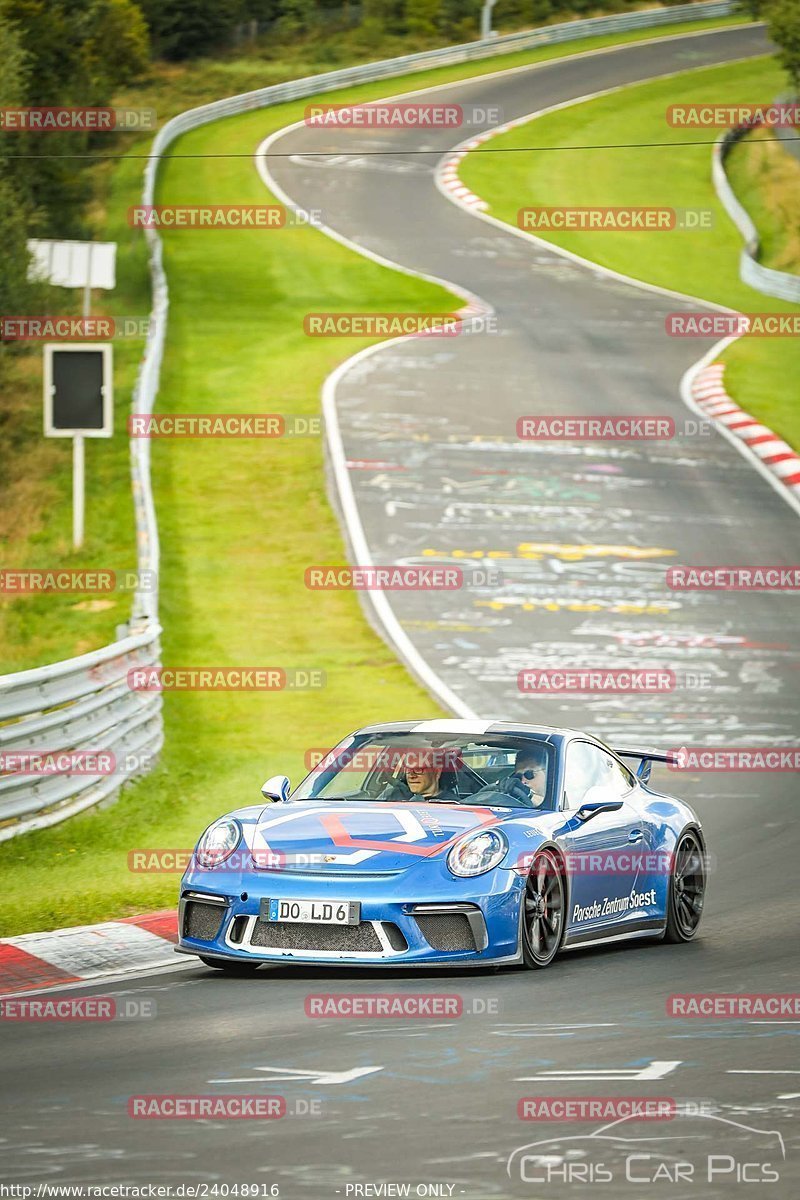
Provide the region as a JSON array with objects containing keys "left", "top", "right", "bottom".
[{"left": 178, "top": 864, "right": 523, "bottom": 966}]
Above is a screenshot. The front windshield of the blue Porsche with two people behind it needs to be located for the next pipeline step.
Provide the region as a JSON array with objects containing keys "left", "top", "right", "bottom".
[{"left": 291, "top": 732, "right": 554, "bottom": 809}]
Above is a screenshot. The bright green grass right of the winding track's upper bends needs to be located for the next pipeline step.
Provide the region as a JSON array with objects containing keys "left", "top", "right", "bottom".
[{"left": 461, "top": 59, "right": 800, "bottom": 446}]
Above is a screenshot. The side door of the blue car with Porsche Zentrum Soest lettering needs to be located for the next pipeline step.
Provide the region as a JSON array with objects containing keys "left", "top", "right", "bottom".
[{"left": 561, "top": 739, "right": 655, "bottom": 941}]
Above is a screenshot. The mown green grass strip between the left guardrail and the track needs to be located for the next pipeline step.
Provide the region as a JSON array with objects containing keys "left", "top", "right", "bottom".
[{"left": 0, "top": 9, "right": 753, "bottom": 936}]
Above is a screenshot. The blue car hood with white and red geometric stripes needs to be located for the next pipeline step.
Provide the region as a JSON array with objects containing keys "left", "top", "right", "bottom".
[{"left": 251, "top": 800, "right": 507, "bottom": 875}]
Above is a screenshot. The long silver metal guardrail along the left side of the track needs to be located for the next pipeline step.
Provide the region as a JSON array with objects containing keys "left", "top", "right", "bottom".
[{"left": 0, "top": 0, "right": 736, "bottom": 841}]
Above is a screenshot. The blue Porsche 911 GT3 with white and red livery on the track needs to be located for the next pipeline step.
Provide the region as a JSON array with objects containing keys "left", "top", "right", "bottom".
[{"left": 179, "top": 720, "right": 706, "bottom": 972}]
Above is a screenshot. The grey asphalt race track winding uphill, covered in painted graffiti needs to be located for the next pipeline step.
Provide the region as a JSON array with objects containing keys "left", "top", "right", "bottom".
[{"left": 0, "top": 28, "right": 800, "bottom": 1200}]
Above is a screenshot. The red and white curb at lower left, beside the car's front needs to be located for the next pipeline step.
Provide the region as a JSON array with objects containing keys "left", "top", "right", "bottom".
[{"left": 0, "top": 908, "right": 178, "bottom": 996}]
